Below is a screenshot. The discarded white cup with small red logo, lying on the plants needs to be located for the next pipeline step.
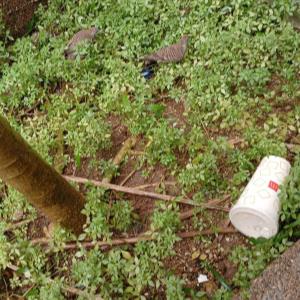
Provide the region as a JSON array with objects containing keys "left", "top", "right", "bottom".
[{"left": 229, "top": 156, "right": 291, "bottom": 238}]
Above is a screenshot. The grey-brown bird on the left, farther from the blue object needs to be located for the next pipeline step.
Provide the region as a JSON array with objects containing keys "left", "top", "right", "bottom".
[{"left": 64, "top": 27, "right": 99, "bottom": 59}]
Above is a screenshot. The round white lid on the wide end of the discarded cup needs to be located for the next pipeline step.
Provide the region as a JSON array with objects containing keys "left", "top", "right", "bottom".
[{"left": 229, "top": 207, "right": 278, "bottom": 238}]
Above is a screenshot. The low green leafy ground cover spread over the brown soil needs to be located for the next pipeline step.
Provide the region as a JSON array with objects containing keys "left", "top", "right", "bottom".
[{"left": 0, "top": 0, "right": 300, "bottom": 299}]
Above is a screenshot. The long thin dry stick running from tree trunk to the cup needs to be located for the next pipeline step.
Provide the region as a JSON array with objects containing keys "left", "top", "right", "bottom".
[{"left": 63, "top": 175, "right": 228, "bottom": 211}]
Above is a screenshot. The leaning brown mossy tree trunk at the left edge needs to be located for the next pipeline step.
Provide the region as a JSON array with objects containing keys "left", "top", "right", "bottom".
[{"left": 0, "top": 116, "right": 86, "bottom": 234}]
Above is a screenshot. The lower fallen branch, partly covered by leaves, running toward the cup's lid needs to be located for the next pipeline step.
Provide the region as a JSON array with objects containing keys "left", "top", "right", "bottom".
[{"left": 31, "top": 228, "right": 237, "bottom": 250}]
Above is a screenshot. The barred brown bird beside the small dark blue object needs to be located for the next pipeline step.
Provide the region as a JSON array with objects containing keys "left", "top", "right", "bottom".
[{"left": 143, "top": 35, "right": 189, "bottom": 64}]
